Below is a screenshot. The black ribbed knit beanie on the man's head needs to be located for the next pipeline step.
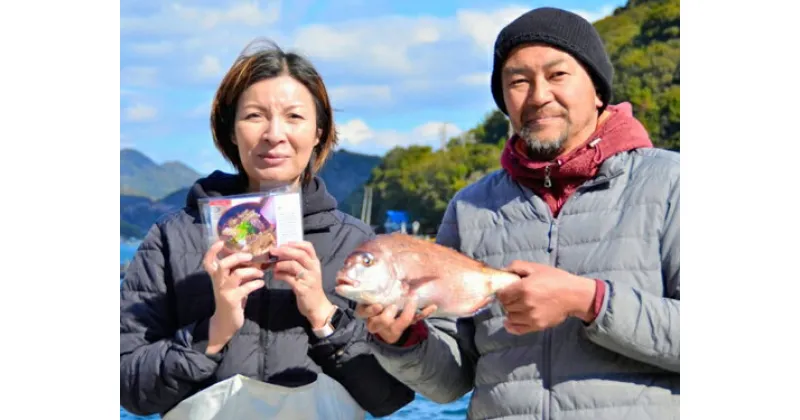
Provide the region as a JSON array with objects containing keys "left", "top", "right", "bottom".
[{"left": 492, "top": 7, "right": 614, "bottom": 115}]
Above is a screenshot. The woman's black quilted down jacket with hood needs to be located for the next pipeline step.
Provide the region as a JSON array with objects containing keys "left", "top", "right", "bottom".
[{"left": 120, "top": 171, "right": 414, "bottom": 416}]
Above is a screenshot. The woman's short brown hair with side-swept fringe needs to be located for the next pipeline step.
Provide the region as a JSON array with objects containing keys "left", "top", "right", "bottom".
[{"left": 211, "top": 39, "right": 338, "bottom": 183}]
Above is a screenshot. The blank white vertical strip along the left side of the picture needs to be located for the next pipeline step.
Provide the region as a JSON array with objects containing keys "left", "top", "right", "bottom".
[{"left": 0, "top": 1, "right": 120, "bottom": 419}]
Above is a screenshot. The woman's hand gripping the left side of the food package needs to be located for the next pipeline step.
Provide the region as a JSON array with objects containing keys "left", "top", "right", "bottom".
[{"left": 203, "top": 241, "right": 264, "bottom": 354}]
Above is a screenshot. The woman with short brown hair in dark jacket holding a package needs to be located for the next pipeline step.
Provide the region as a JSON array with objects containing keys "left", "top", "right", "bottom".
[{"left": 120, "top": 38, "right": 414, "bottom": 416}]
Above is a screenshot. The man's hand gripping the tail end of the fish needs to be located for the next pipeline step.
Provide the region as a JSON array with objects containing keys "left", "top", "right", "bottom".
[{"left": 497, "top": 261, "right": 597, "bottom": 335}]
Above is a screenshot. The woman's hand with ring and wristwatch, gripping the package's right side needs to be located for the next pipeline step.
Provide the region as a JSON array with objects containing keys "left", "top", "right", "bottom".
[{"left": 270, "top": 241, "right": 336, "bottom": 329}]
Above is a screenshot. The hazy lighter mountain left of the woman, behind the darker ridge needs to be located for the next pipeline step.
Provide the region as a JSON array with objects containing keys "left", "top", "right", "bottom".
[{"left": 119, "top": 149, "right": 205, "bottom": 199}]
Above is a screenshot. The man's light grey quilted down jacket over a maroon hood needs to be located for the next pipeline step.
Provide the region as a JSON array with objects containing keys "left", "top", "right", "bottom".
[{"left": 371, "top": 148, "right": 680, "bottom": 420}]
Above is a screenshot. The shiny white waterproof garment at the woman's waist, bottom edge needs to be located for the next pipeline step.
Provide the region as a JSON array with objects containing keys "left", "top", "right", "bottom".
[{"left": 163, "top": 373, "right": 366, "bottom": 420}]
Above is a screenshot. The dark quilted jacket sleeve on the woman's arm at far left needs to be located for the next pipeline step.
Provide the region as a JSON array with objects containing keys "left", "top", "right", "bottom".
[{"left": 119, "top": 225, "right": 224, "bottom": 415}]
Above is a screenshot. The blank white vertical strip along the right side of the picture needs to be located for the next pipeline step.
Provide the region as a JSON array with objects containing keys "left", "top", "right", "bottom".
[{"left": 681, "top": 0, "right": 800, "bottom": 420}]
